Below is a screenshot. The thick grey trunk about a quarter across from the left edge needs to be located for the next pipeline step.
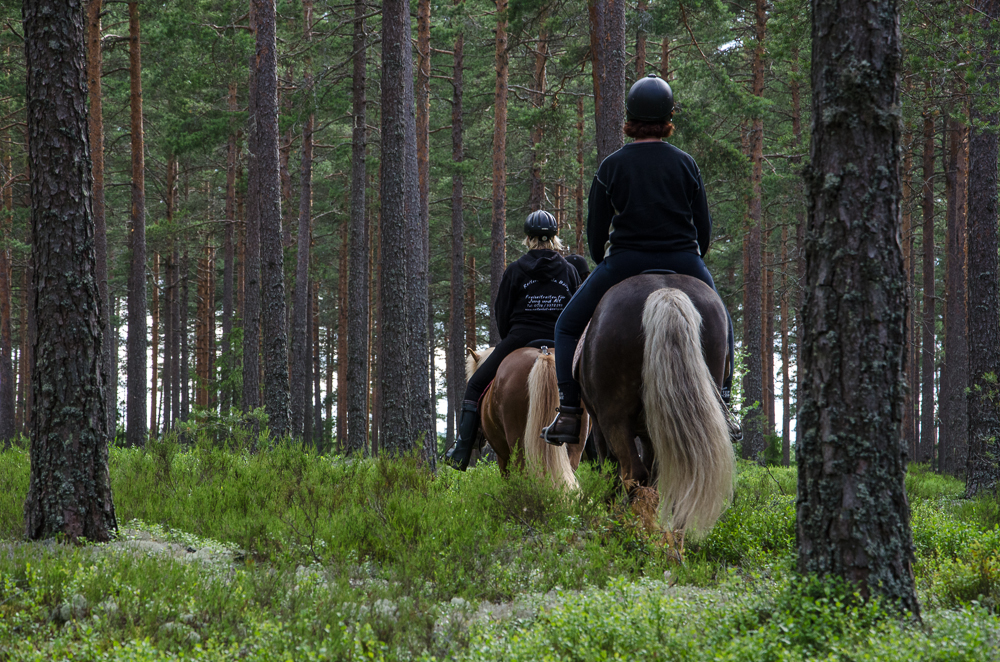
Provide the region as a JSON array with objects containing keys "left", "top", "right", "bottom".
[{"left": 252, "top": 0, "right": 291, "bottom": 437}]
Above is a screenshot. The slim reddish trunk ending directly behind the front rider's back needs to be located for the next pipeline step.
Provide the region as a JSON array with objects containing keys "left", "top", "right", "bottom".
[{"left": 490, "top": 0, "right": 509, "bottom": 345}]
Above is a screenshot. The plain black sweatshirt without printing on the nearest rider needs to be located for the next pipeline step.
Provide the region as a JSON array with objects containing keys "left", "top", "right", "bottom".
[{"left": 587, "top": 142, "right": 712, "bottom": 263}]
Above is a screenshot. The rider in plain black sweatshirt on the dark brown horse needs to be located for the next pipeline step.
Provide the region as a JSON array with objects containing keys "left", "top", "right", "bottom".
[{"left": 543, "top": 74, "right": 733, "bottom": 445}]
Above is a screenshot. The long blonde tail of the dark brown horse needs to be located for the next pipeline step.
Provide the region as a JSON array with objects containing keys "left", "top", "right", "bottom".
[{"left": 642, "top": 288, "right": 736, "bottom": 537}]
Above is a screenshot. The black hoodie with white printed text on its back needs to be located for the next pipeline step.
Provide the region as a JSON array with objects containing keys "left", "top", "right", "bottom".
[{"left": 494, "top": 249, "right": 580, "bottom": 339}]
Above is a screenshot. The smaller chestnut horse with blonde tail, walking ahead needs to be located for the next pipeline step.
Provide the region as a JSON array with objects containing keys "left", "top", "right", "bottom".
[{"left": 466, "top": 347, "right": 587, "bottom": 490}]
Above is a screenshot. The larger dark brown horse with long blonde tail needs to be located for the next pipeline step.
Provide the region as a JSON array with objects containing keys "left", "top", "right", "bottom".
[{"left": 577, "top": 274, "right": 735, "bottom": 536}]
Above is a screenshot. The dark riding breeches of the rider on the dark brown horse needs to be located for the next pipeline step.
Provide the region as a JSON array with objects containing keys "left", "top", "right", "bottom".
[{"left": 555, "top": 251, "right": 734, "bottom": 407}]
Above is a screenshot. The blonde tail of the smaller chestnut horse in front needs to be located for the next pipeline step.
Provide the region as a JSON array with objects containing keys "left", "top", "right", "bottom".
[{"left": 524, "top": 350, "right": 579, "bottom": 490}]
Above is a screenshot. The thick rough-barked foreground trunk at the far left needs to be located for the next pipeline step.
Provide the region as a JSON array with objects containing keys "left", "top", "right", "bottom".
[{"left": 22, "top": 0, "right": 116, "bottom": 541}]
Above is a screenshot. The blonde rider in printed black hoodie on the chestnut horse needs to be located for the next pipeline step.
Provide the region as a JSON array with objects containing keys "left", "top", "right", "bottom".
[{"left": 447, "top": 210, "right": 580, "bottom": 471}]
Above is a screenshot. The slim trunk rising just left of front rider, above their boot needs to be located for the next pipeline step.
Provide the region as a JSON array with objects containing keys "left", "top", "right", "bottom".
[{"left": 448, "top": 23, "right": 465, "bottom": 452}]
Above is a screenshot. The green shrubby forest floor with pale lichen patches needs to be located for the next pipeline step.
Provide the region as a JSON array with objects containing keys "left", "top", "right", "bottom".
[{"left": 0, "top": 438, "right": 1000, "bottom": 662}]
